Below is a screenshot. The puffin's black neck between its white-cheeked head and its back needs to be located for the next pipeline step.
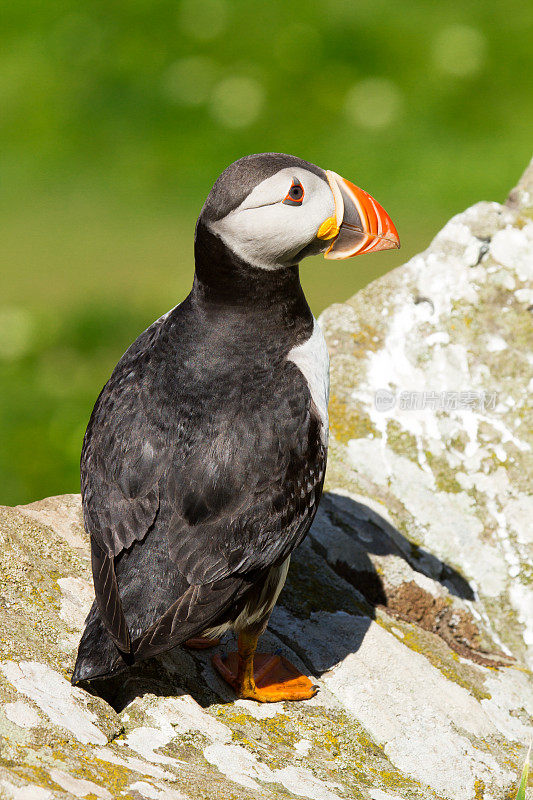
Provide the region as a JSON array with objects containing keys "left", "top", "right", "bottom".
[{"left": 191, "top": 220, "right": 313, "bottom": 340}]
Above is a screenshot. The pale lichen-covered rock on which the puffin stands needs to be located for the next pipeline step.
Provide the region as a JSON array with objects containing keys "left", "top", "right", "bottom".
[{"left": 0, "top": 168, "right": 533, "bottom": 800}]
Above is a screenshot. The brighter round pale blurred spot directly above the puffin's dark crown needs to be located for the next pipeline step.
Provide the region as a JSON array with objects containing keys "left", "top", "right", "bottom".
[{"left": 211, "top": 76, "right": 264, "bottom": 128}]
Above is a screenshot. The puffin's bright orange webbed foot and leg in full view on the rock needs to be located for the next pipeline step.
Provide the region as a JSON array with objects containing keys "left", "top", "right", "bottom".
[{"left": 213, "top": 633, "right": 317, "bottom": 703}]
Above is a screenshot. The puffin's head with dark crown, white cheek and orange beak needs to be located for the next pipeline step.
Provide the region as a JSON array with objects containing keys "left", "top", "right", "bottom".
[{"left": 193, "top": 153, "right": 399, "bottom": 271}]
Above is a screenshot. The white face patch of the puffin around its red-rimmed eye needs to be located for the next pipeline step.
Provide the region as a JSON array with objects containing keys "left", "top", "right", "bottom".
[{"left": 210, "top": 167, "right": 335, "bottom": 269}]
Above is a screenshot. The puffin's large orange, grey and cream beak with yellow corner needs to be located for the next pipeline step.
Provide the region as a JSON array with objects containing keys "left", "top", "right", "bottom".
[{"left": 317, "top": 169, "right": 400, "bottom": 259}]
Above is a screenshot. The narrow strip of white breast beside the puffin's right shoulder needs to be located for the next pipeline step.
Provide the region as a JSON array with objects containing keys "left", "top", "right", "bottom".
[{"left": 287, "top": 320, "right": 329, "bottom": 444}]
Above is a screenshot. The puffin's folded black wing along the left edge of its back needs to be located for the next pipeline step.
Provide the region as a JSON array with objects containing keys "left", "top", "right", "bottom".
[{"left": 81, "top": 321, "right": 170, "bottom": 653}]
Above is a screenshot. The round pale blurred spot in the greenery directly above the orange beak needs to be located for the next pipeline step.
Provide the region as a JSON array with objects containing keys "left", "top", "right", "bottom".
[{"left": 345, "top": 78, "right": 402, "bottom": 130}]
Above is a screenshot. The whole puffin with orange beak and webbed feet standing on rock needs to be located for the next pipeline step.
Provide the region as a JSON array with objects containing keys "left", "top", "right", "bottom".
[{"left": 72, "top": 153, "right": 400, "bottom": 702}]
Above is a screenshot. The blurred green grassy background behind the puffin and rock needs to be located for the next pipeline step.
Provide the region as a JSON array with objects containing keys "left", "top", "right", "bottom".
[{"left": 0, "top": 0, "right": 533, "bottom": 504}]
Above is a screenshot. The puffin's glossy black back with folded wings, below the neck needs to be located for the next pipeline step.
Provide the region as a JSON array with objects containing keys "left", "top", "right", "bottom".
[{"left": 82, "top": 310, "right": 326, "bottom": 655}]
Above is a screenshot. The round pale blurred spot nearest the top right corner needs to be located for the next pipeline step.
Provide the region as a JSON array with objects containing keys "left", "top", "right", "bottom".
[{"left": 433, "top": 25, "right": 487, "bottom": 77}]
